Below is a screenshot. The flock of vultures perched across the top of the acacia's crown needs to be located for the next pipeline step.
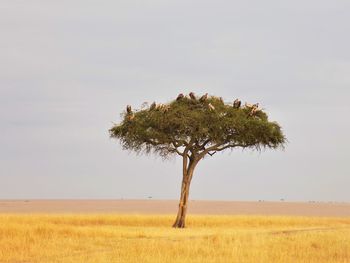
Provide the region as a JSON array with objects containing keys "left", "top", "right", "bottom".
[{"left": 126, "top": 92, "right": 260, "bottom": 120}]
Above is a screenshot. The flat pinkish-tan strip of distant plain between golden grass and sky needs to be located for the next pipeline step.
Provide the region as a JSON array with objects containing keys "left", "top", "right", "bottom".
[{"left": 0, "top": 200, "right": 350, "bottom": 217}]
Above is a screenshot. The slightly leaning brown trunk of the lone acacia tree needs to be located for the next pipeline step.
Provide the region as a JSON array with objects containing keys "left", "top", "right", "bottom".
[{"left": 173, "top": 159, "right": 196, "bottom": 228}]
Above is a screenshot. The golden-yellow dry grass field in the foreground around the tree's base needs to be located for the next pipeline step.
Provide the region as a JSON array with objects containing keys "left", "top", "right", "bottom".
[{"left": 0, "top": 214, "right": 350, "bottom": 263}]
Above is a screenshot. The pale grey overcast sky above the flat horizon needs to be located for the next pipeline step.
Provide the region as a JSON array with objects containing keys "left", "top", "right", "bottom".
[{"left": 0, "top": 0, "right": 350, "bottom": 202}]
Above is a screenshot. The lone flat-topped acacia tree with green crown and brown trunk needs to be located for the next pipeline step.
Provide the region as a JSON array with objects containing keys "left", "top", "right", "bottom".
[{"left": 109, "top": 93, "right": 286, "bottom": 228}]
